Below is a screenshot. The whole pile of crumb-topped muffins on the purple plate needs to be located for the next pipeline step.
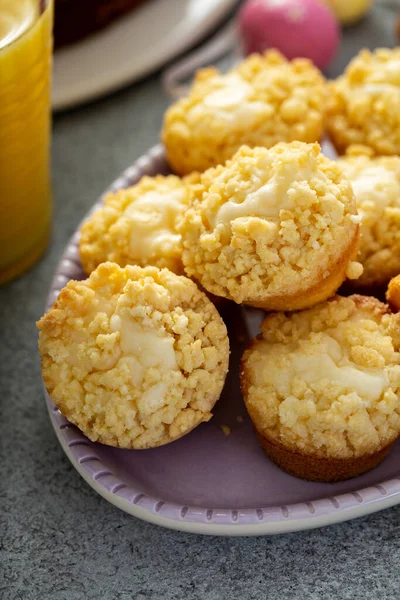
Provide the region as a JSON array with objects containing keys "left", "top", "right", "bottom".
[{"left": 38, "top": 49, "right": 400, "bottom": 481}]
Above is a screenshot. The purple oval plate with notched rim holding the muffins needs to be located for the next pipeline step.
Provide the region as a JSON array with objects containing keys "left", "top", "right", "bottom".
[{"left": 46, "top": 146, "right": 400, "bottom": 535}]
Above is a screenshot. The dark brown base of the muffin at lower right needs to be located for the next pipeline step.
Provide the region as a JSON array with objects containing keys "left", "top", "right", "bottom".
[{"left": 257, "top": 432, "right": 394, "bottom": 482}]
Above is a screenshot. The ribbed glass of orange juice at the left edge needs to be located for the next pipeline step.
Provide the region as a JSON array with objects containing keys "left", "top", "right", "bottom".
[{"left": 0, "top": 0, "right": 53, "bottom": 283}]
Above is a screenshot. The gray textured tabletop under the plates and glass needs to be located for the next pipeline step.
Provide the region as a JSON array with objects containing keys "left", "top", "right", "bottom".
[{"left": 0, "top": 2, "right": 400, "bottom": 600}]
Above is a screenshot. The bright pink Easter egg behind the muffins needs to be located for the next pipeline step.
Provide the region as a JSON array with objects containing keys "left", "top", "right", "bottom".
[{"left": 239, "top": 0, "right": 340, "bottom": 70}]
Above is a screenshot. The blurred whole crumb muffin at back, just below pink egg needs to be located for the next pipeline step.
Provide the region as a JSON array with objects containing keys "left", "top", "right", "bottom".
[{"left": 162, "top": 50, "right": 326, "bottom": 175}]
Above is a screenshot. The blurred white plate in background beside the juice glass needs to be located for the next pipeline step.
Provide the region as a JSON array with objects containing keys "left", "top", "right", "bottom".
[{"left": 52, "top": 0, "right": 238, "bottom": 110}]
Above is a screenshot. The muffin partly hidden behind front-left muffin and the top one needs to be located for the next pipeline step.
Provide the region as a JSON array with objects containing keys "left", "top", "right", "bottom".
[{"left": 79, "top": 175, "right": 196, "bottom": 275}]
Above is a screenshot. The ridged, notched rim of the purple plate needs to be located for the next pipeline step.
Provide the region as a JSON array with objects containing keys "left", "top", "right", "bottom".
[{"left": 45, "top": 144, "right": 400, "bottom": 536}]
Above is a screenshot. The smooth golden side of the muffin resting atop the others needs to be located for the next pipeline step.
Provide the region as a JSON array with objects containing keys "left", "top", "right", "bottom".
[{"left": 247, "top": 227, "right": 360, "bottom": 312}]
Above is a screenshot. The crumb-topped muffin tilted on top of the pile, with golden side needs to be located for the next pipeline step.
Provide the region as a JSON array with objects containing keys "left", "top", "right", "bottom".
[{"left": 179, "top": 142, "right": 362, "bottom": 310}]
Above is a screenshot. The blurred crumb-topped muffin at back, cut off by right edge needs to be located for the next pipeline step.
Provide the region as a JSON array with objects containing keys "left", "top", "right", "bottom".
[{"left": 326, "top": 48, "right": 400, "bottom": 155}]
